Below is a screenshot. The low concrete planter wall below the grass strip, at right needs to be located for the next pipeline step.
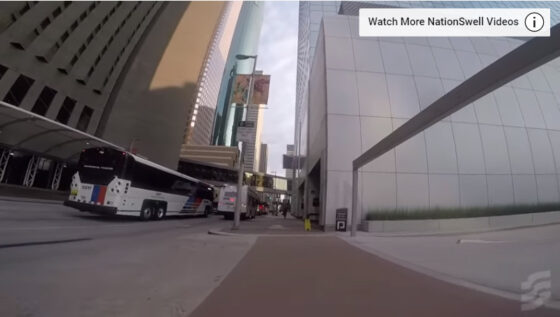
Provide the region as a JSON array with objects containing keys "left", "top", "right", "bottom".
[{"left": 361, "top": 211, "right": 560, "bottom": 233}]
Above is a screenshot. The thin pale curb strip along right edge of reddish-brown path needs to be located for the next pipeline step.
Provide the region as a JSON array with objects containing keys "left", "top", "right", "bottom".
[{"left": 341, "top": 238, "right": 560, "bottom": 310}]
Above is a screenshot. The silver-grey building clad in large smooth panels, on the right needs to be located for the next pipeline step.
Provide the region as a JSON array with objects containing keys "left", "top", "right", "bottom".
[{"left": 296, "top": 2, "right": 560, "bottom": 227}]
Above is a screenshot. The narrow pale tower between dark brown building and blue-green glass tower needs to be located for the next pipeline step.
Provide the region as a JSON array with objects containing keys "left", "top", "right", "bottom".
[{"left": 184, "top": 2, "right": 243, "bottom": 145}]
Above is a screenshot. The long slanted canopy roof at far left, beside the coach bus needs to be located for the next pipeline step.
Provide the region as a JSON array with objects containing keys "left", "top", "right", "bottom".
[{"left": 0, "top": 101, "right": 124, "bottom": 162}]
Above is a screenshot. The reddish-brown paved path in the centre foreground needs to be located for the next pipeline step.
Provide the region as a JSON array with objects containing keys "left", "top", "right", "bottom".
[{"left": 191, "top": 237, "right": 558, "bottom": 317}]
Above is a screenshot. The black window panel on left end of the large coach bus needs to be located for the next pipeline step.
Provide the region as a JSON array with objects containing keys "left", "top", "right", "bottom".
[{"left": 78, "top": 148, "right": 126, "bottom": 185}]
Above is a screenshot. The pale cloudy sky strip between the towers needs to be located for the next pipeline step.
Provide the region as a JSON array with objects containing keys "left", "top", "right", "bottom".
[{"left": 257, "top": 1, "right": 298, "bottom": 176}]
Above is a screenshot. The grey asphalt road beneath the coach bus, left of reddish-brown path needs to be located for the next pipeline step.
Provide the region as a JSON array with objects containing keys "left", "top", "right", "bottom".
[{"left": 0, "top": 200, "right": 255, "bottom": 316}]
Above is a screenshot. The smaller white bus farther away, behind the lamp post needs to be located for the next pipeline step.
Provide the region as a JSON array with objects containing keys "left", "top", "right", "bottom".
[{"left": 216, "top": 185, "right": 259, "bottom": 220}]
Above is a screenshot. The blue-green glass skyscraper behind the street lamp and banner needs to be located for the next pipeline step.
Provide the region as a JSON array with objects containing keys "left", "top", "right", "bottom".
[{"left": 212, "top": 1, "right": 265, "bottom": 146}]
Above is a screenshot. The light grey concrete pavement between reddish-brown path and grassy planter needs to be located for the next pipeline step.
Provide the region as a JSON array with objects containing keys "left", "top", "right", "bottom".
[{"left": 344, "top": 224, "right": 560, "bottom": 306}]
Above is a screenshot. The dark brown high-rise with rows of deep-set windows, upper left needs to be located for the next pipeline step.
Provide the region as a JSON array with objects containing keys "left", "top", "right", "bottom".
[{"left": 0, "top": 1, "right": 224, "bottom": 168}]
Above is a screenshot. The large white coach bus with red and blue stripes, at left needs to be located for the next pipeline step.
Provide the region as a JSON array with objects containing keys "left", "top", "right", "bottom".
[{"left": 64, "top": 148, "right": 214, "bottom": 220}]
